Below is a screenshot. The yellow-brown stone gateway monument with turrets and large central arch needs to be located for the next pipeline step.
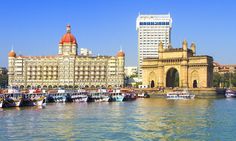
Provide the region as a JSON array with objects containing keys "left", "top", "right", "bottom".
[{"left": 142, "top": 40, "right": 213, "bottom": 88}]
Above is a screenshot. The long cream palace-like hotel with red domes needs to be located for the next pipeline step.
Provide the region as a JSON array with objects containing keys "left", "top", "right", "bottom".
[{"left": 8, "top": 25, "right": 125, "bottom": 88}]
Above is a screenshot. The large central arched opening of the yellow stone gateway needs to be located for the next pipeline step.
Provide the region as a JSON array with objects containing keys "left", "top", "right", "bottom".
[{"left": 166, "top": 68, "right": 179, "bottom": 87}]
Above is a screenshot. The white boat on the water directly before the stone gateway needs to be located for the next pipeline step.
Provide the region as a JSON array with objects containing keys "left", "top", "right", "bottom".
[{"left": 166, "top": 90, "right": 195, "bottom": 100}]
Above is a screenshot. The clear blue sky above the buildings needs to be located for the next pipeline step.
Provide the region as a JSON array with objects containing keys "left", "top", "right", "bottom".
[{"left": 0, "top": 0, "right": 236, "bottom": 67}]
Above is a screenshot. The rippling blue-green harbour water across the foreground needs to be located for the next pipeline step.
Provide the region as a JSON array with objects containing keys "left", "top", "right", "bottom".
[{"left": 0, "top": 99, "right": 236, "bottom": 140}]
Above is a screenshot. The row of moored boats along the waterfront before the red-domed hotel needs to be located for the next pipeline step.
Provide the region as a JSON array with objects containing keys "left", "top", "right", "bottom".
[{"left": 0, "top": 90, "right": 139, "bottom": 108}]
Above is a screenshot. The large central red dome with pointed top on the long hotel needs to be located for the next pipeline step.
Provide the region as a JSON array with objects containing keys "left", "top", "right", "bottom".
[{"left": 60, "top": 25, "right": 77, "bottom": 44}]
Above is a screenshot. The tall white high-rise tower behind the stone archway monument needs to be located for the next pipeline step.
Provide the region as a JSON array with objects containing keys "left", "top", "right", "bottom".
[{"left": 136, "top": 14, "right": 172, "bottom": 78}]
